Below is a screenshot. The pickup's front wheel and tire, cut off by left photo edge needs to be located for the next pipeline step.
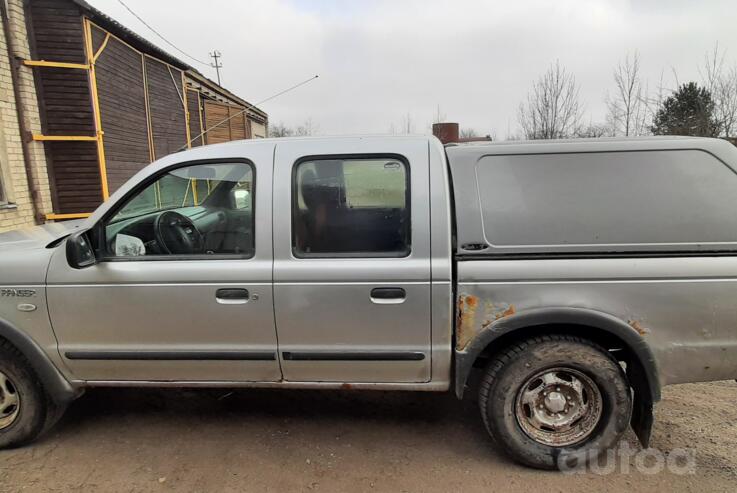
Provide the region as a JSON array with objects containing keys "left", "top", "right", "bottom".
[{"left": 0, "top": 340, "right": 47, "bottom": 449}]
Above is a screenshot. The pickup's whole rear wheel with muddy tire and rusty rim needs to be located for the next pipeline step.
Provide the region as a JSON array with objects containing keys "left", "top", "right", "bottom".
[{"left": 479, "top": 335, "right": 632, "bottom": 469}]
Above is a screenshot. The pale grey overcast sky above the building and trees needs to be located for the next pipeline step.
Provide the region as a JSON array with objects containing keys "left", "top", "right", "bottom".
[{"left": 89, "top": 0, "right": 737, "bottom": 139}]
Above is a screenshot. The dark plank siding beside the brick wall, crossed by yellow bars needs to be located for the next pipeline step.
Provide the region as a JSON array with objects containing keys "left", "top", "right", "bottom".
[{"left": 27, "top": 0, "right": 102, "bottom": 213}]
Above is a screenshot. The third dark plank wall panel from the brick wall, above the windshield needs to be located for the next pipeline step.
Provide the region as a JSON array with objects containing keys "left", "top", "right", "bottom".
[{"left": 146, "top": 56, "right": 187, "bottom": 159}]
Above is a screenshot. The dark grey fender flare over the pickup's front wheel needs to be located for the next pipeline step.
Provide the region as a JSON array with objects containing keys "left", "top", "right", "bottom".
[{"left": 0, "top": 318, "right": 80, "bottom": 407}]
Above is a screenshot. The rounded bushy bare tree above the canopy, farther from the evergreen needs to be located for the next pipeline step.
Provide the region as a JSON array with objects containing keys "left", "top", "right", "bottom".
[{"left": 518, "top": 60, "right": 582, "bottom": 139}]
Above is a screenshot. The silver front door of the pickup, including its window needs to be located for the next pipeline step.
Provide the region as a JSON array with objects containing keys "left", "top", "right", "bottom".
[{"left": 48, "top": 145, "right": 281, "bottom": 382}]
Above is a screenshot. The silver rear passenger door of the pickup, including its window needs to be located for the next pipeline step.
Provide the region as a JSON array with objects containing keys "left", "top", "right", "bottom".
[{"left": 273, "top": 139, "right": 431, "bottom": 383}]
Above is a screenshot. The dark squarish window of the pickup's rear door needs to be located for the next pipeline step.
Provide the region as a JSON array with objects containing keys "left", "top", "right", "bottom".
[{"left": 292, "top": 157, "right": 410, "bottom": 257}]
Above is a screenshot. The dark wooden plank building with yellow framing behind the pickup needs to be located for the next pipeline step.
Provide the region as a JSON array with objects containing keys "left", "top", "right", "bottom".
[{"left": 23, "top": 0, "right": 268, "bottom": 219}]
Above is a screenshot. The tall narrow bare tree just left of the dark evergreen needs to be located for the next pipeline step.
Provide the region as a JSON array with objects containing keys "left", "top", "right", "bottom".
[{"left": 606, "top": 52, "right": 648, "bottom": 136}]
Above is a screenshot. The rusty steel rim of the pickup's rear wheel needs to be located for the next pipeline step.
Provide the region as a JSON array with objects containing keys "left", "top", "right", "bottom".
[{"left": 515, "top": 367, "right": 603, "bottom": 447}]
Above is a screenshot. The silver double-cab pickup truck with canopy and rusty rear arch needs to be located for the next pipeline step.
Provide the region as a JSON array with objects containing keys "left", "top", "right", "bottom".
[{"left": 0, "top": 136, "right": 737, "bottom": 468}]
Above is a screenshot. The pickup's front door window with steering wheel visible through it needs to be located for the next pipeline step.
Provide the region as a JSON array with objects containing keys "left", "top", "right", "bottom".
[{"left": 105, "top": 162, "right": 254, "bottom": 257}]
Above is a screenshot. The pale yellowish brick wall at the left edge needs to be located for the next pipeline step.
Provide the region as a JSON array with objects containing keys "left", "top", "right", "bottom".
[{"left": 0, "top": 0, "right": 52, "bottom": 231}]
